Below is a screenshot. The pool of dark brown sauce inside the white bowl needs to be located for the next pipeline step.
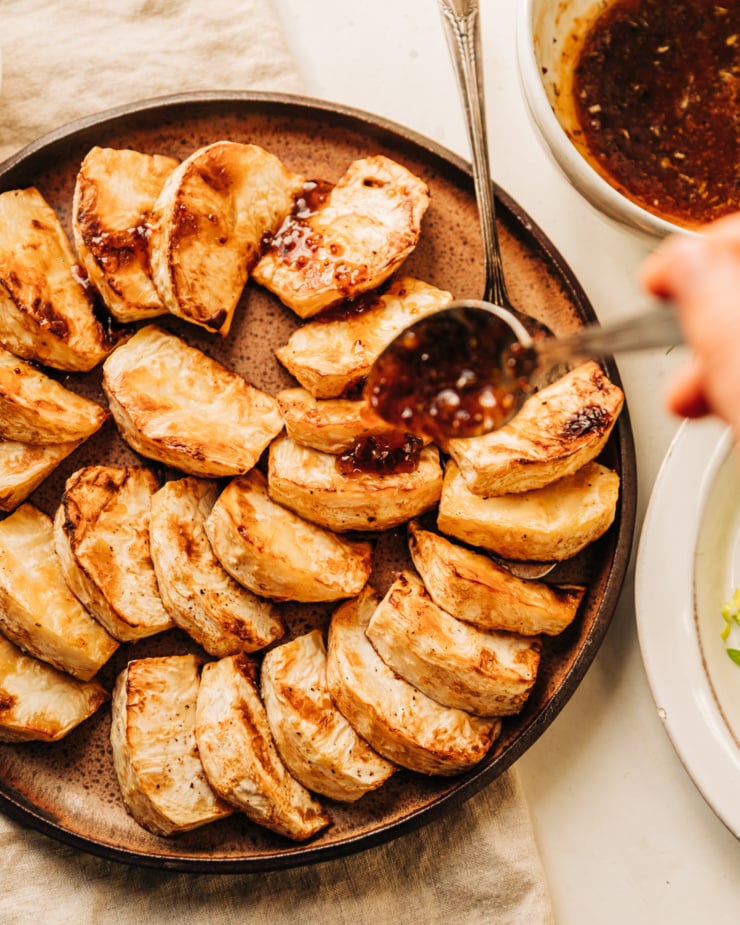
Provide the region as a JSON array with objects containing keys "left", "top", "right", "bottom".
[{"left": 573, "top": 0, "right": 740, "bottom": 227}]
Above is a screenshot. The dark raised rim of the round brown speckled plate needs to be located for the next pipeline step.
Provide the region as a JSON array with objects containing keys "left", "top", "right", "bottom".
[{"left": 0, "top": 91, "right": 637, "bottom": 873}]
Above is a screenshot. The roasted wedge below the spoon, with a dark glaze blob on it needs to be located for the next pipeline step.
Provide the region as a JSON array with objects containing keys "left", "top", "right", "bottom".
[{"left": 268, "top": 436, "right": 442, "bottom": 532}]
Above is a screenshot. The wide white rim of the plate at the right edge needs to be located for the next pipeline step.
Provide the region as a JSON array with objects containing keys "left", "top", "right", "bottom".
[{"left": 635, "top": 417, "right": 740, "bottom": 839}]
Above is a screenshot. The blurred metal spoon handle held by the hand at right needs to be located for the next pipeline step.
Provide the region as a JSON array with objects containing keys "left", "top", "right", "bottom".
[{"left": 536, "top": 304, "right": 683, "bottom": 364}]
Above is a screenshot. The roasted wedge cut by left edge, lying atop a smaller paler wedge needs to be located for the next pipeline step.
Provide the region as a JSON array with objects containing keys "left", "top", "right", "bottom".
[{"left": 0, "top": 347, "right": 108, "bottom": 444}]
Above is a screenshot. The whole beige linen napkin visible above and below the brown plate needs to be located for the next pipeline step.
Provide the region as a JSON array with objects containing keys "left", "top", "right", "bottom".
[{"left": 0, "top": 0, "right": 553, "bottom": 925}]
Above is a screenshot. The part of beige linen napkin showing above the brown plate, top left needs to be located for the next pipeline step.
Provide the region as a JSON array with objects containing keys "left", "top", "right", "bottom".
[{"left": 0, "top": 0, "right": 301, "bottom": 160}]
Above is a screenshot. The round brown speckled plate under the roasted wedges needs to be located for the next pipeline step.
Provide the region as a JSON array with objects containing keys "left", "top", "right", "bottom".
[{"left": 0, "top": 93, "right": 636, "bottom": 873}]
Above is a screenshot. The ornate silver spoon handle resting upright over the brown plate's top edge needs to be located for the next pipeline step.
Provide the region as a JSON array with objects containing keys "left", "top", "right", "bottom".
[{"left": 437, "top": 0, "right": 509, "bottom": 305}]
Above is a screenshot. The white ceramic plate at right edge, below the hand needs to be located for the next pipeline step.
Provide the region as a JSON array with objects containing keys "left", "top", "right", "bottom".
[{"left": 635, "top": 420, "right": 740, "bottom": 838}]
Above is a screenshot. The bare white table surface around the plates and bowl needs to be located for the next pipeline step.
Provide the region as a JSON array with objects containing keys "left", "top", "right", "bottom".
[{"left": 274, "top": 0, "right": 740, "bottom": 925}]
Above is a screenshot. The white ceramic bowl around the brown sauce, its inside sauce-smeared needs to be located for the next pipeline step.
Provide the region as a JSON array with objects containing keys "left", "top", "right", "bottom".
[{"left": 517, "top": 0, "right": 686, "bottom": 237}]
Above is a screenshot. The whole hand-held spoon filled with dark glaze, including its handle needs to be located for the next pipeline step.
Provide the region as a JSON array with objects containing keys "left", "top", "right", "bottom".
[{"left": 365, "top": 299, "right": 682, "bottom": 446}]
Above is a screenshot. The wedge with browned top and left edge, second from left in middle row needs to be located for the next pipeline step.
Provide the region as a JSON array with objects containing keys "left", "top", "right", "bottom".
[{"left": 54, "top": 466, "right": 175, "bottom": 642}]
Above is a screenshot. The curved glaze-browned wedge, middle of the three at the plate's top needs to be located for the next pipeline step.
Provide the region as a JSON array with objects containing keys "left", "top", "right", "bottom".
[{"left": 150, "top": 141, "right": 304, "bottom": 335}]
